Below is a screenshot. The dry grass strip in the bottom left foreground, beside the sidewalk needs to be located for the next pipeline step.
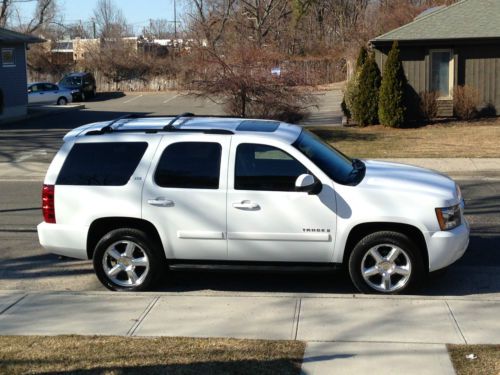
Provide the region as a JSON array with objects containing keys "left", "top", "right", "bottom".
[{"left": 0, "top": 336, "right": 305, "bottom": 375}]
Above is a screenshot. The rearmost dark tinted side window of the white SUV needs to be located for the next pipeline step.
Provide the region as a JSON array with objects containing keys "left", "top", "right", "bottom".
[{"left": 56, "top": 142, "right": 148, "bottom": 186}]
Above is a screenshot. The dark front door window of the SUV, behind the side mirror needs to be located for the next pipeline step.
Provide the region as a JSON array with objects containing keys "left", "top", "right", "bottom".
[{"left": 234, "top": 144, "right": 308, "bottom": 191}]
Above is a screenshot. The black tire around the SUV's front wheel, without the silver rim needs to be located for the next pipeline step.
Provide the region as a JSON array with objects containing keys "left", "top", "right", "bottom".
[{"left": 348, "top": 231, "right": 425, "bottom": 294}]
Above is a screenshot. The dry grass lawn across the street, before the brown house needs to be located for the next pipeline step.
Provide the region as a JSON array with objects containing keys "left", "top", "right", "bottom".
[{"left": 310, "top": 118, "right": 500, "bottom": 158}]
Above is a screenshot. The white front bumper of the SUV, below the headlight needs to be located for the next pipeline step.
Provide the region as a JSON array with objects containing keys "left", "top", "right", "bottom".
[{"left": 427, "top": 218, "right": 470, "bottom": 272}]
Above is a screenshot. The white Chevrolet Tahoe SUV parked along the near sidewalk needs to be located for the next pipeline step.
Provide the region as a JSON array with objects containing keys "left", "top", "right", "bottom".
[{"left": 38, "top": 114, "right": 469, "bottom": 293}]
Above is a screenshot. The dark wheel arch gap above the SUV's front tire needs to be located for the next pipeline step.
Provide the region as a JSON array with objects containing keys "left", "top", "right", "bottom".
[{"left": 342, "top": 222, "right": 429, "bottom": 270}]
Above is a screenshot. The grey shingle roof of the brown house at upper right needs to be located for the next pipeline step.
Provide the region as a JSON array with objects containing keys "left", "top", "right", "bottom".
[{"left": 371, "top": 0, "right": 500, "bottom": 44}]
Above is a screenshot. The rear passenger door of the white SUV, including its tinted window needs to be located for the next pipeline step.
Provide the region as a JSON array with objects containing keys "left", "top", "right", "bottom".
[{"left": 142, "top": 133, "right": 231, "bottom": 260}]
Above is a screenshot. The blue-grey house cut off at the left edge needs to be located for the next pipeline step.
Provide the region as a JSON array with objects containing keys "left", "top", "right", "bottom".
[{"left": 0, "top": 28, "right": 43, "bottom": 121}]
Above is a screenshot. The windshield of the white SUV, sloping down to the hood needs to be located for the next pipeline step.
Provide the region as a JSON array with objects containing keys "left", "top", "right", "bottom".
[{"left": 293, "top": 129, "right": 365, "bottom": 185}]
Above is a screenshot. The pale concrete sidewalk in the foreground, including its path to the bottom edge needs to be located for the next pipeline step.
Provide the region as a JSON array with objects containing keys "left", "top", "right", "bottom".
[{"left": 0, "top": 291, "right": 500, "bottom": 374}]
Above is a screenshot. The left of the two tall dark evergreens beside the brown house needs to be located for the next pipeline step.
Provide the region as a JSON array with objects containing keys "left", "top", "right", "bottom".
[{"left": 352, "top": 54, "right": 381, "bottom": 126}]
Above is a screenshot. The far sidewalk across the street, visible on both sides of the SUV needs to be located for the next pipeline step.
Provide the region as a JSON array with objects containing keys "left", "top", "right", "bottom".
[{"left": 0, "top": 159, "right": 500, "bottom": 181}]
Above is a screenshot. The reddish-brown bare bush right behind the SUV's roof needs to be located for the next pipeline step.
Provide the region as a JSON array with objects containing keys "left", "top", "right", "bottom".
[{"left": 188, "top": 43, "right": 314, "bottom": 122}]
